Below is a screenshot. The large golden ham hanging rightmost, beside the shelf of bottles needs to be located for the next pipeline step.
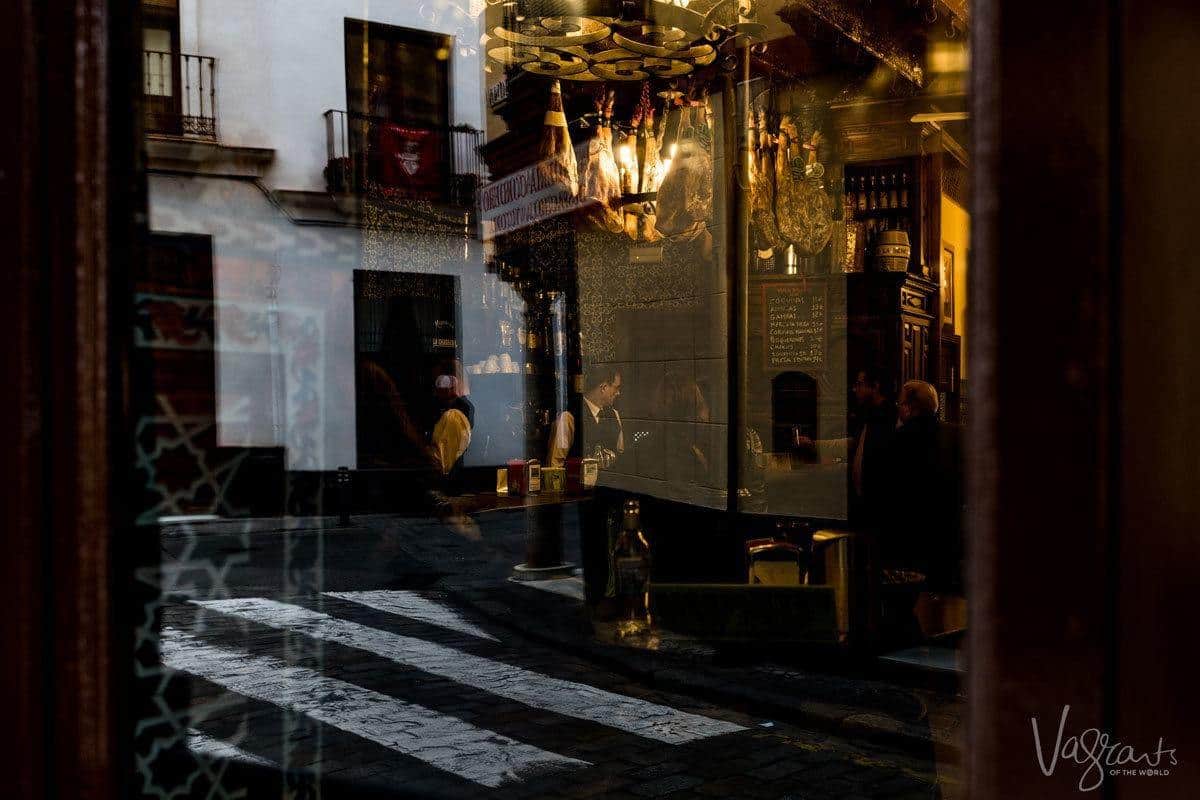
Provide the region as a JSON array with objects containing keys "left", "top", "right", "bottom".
[{"left": 775, "top": 116, "right": 833, "bottom": 255}]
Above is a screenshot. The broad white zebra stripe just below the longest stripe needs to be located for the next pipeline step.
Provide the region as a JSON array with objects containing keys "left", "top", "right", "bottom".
[{"left": 161, "top": 628, "right": 589, "bottom": 787}]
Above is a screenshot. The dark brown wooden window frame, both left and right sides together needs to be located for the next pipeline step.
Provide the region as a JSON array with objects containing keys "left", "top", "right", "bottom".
[{"left": 0, "top": 0, "right": 1200, "bottom": 800}]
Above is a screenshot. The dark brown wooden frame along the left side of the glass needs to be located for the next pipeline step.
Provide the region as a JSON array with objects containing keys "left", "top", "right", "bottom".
[{"left": 0, "top": 0, "right": 145, "bottom": 799}]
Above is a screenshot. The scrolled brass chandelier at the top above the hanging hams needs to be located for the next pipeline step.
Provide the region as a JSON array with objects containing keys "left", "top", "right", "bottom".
[{"left": 482, "top": 0, "right": 764, "bottom": 80}]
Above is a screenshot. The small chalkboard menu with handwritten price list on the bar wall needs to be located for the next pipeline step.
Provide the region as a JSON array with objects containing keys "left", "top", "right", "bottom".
[{"left": 762, "top": 281, "right": 828, "bottom": 369}]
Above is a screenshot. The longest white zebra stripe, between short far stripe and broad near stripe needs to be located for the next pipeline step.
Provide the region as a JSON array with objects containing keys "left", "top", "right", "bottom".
[{"left": 192, "top": 597, "right": 744, "bottom": 745}]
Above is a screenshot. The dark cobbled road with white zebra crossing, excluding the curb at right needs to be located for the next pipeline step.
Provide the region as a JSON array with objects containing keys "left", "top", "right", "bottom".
[{"left": 139, "top": 515, "right": 962, "bottom": 800}]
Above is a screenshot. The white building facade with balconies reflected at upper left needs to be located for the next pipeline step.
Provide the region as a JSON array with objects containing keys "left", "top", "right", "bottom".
[{"left": 145, "top": 0, "right": 523, "bottom": 482}]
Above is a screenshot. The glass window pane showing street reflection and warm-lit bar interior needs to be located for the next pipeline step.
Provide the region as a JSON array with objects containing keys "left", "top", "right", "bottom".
[{"left": 131, "top": 0, "right": 971, "bottom": 798}]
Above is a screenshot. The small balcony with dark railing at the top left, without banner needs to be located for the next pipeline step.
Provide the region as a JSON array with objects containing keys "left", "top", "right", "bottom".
[{"left": 142, "top": 50, "right": 217, "bottom": 139}]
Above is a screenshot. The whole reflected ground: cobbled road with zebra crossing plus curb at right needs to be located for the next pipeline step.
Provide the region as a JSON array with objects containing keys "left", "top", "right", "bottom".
[{"left": 140, "top": 512, "right": 961, "bottom": 798}]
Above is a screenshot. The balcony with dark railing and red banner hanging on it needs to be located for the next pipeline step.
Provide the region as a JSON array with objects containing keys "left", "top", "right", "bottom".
[{"left": 324, "top": 109, "right": 484, "bottom": 209}]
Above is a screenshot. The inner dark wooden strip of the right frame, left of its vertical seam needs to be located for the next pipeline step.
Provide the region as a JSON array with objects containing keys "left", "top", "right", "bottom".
[{"left": 965, "top": 0, "right": 1117, "bottom": 800}]
